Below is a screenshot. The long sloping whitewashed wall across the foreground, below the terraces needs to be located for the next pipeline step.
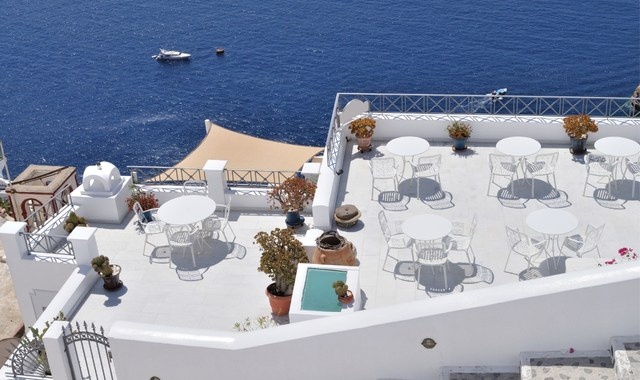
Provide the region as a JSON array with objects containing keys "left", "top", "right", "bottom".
[{"left": 109, "top": 263, "right": 640, "bottom": 380}]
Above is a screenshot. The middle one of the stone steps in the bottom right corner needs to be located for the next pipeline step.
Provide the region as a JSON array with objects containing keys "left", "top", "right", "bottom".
[{"left": 520, "top": 350, "right": 616, "bottom": 380}]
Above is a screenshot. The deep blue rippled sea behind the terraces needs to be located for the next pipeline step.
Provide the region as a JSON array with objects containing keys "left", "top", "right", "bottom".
[{"left": 0, "top": 0, "right": 640, "bottom": 177}]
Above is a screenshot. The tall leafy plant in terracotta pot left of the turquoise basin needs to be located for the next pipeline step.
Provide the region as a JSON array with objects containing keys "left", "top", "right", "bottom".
[{"left": 254, "top": 228, "right": 309, "bottom": 316}]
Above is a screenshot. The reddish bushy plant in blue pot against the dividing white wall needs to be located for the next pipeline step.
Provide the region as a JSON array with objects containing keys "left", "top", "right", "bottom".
[{"left": 267, "top": 177, "right": 316, "bottom": 228}]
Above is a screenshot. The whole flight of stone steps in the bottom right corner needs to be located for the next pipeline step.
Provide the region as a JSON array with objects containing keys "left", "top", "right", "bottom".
[{"left": 441, "top": 335, "right": 640, "bottom": 380}]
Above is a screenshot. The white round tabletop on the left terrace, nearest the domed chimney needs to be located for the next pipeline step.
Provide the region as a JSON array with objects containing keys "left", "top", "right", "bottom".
[{"left": 158, "top": 195, "right": 216, "bottom": 226}]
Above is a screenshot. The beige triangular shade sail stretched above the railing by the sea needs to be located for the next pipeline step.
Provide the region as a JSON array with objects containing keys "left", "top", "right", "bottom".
[{"left": 175, "top": 123, "right": 324, "bottom": 171}]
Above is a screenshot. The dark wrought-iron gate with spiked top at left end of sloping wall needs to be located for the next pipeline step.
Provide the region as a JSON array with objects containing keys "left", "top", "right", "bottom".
[{"left": 63, "top": 322, "right": 116, "bottom": 380}]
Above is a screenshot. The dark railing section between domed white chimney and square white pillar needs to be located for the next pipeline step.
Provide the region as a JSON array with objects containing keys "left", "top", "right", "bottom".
[{"left": 127, "top": 166, "right": 207, "bottom": 186}]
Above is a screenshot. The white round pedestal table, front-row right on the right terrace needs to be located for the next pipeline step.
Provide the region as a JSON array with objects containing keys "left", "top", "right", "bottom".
[{"left": 526, "top": 208, "right": 578, "bottom": 256}]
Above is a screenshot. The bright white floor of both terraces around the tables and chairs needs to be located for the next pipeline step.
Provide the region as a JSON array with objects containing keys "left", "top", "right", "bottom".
[{"left": 74, "top": 142, "right": 640, "bottom": 330}]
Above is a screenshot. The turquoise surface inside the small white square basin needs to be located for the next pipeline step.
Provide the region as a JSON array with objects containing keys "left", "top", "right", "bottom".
[{"left": 302, "top": 268, "right": 347, "bottom": 311}]
